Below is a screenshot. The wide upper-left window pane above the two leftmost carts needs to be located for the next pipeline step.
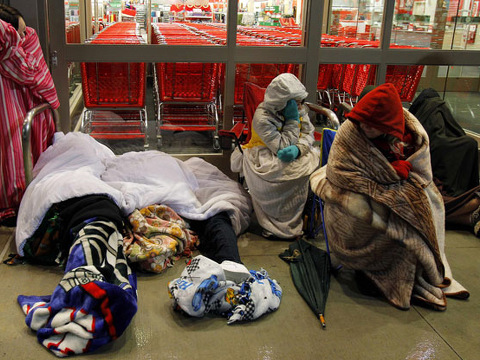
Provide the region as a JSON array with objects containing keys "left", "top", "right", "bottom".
[{"left": 65, "top": 0, "right": 228, "bottom": 45}]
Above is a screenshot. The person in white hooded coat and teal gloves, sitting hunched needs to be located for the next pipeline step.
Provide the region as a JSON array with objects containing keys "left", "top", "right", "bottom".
[{"left": 231, "top": 73, "right": 320, "bottom": 239}]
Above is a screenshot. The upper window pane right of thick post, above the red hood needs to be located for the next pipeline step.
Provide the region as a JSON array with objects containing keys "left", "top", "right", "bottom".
[{"left": 321, "top": 0, "right": 383, "bottom": 47}]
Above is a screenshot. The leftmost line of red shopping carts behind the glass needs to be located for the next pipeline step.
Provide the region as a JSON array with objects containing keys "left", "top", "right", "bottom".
[{"left": 81, "top": 23, "right": 148, "bottom": 152}]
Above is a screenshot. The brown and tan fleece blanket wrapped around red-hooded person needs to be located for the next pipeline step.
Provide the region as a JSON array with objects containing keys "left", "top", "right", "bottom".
[{"left": 310, "top": 110, "right": 468, "bottom": 310}]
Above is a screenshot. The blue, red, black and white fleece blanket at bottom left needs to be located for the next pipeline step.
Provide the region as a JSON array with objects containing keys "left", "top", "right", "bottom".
[{"left": 18, "top": 221, "right": 137, "bottom": 357}]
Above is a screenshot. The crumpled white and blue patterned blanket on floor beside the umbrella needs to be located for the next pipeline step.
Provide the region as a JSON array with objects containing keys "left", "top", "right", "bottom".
[{"left": 168, "top": 255, "right": 282, "bottom": 324}]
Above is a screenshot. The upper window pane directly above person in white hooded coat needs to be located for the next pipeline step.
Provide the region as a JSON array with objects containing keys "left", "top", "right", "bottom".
[{"left": 237, "top": 0, "right": 304, "bottom": 46}]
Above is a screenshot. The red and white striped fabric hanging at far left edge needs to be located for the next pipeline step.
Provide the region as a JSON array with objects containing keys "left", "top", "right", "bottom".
[{"left": 0, "top": 20, "right": 60, "bottom": 221}]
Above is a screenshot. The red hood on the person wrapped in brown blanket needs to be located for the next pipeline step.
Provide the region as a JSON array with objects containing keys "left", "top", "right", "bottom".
[{"left": 346, "top": 83, "right": 405, "bottom": 140}]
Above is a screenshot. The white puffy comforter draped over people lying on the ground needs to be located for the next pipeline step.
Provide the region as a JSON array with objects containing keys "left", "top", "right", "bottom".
[{"left": 16, "top": 132, "right": 252, "bottom": 256}]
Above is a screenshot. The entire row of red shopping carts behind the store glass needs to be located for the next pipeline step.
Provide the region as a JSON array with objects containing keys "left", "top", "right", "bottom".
[{"left": 81, "top": 22, "right": 423, "bottom": 150}]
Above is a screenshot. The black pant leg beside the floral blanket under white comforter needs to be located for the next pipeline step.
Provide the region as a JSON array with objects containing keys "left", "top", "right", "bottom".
[{"left": 187, "top": 212, "right": 242, "bottom": 263}]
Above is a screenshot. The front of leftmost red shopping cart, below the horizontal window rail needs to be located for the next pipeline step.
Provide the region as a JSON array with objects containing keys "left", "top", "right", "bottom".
[{"left": 77, "top": 62, "right": 149, "bottom": 154}]
